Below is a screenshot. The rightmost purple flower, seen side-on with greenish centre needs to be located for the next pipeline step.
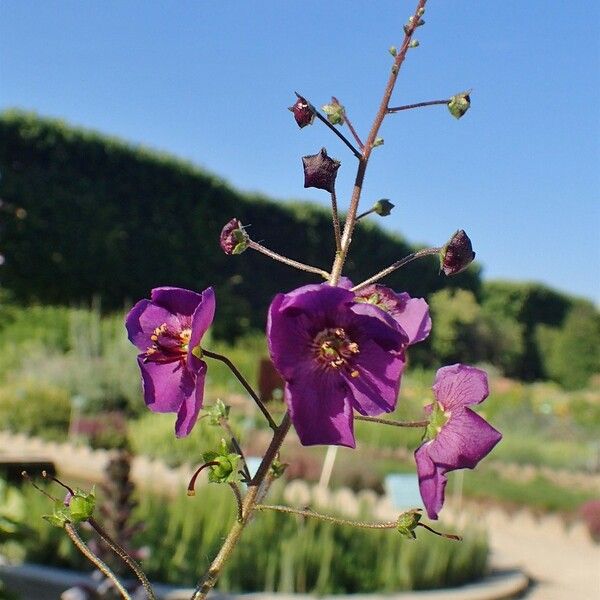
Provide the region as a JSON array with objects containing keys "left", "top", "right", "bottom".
[{"left": 415, "top": 364, "right": 502, "bottom": 519}]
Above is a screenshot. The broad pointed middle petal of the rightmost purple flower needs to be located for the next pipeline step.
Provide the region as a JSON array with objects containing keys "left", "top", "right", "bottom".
[{"left": 429, "top": 408, "right": 502, "bottom": 471}]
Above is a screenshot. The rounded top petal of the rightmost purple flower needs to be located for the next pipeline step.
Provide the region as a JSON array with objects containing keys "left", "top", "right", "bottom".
[{"left": 433, "top": 364, "right": 489, "bottom": 411}]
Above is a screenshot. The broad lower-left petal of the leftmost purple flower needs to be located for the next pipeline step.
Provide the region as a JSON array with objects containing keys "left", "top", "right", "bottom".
[{"left": 138, "top": 355, "right": 194, "bottom": 412}]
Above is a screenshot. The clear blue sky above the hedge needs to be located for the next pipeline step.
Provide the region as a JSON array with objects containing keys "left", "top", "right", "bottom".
[{"left": 0, "top": 0, "right": 600, "bottom": 301}]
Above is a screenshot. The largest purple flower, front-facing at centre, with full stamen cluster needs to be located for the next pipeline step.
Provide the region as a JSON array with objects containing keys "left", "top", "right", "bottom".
[{"left": 267, "top": 284, "right": 408, "bottom": 448}]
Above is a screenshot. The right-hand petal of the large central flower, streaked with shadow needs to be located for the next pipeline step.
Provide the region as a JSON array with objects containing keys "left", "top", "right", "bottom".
[{"left": 344, "top": 341, "right": 405, "bottom": 416}]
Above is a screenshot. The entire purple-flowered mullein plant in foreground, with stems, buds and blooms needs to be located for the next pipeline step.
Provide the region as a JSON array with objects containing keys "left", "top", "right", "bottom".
[{"left": 24, "top": 0, "right": 501, "bottom": 600}]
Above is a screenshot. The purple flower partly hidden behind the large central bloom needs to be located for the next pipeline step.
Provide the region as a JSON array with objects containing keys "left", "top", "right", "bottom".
[{"left": 355, "top": 283, "right": 431, "bottom": 345}]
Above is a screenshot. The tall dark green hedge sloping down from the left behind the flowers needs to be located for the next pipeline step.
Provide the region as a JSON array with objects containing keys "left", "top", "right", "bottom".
[{"left": 0, "top": 111, "right": 480, "bottom": 337}]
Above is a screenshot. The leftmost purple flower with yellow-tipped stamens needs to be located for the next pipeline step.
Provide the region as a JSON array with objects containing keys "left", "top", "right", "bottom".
[{"left": 125, "top": 287, "right": 215, "bottom": 437}]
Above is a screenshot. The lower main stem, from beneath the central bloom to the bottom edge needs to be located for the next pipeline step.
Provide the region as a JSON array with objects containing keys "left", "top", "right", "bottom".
[{"left": 191, "top": 412, "right": 292, "bottom": 600}]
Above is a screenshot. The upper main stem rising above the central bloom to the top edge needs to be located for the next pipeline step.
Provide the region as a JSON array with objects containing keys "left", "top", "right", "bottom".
[{"left": 329, "top": 0, "right": 427, "bottom": 285}]
